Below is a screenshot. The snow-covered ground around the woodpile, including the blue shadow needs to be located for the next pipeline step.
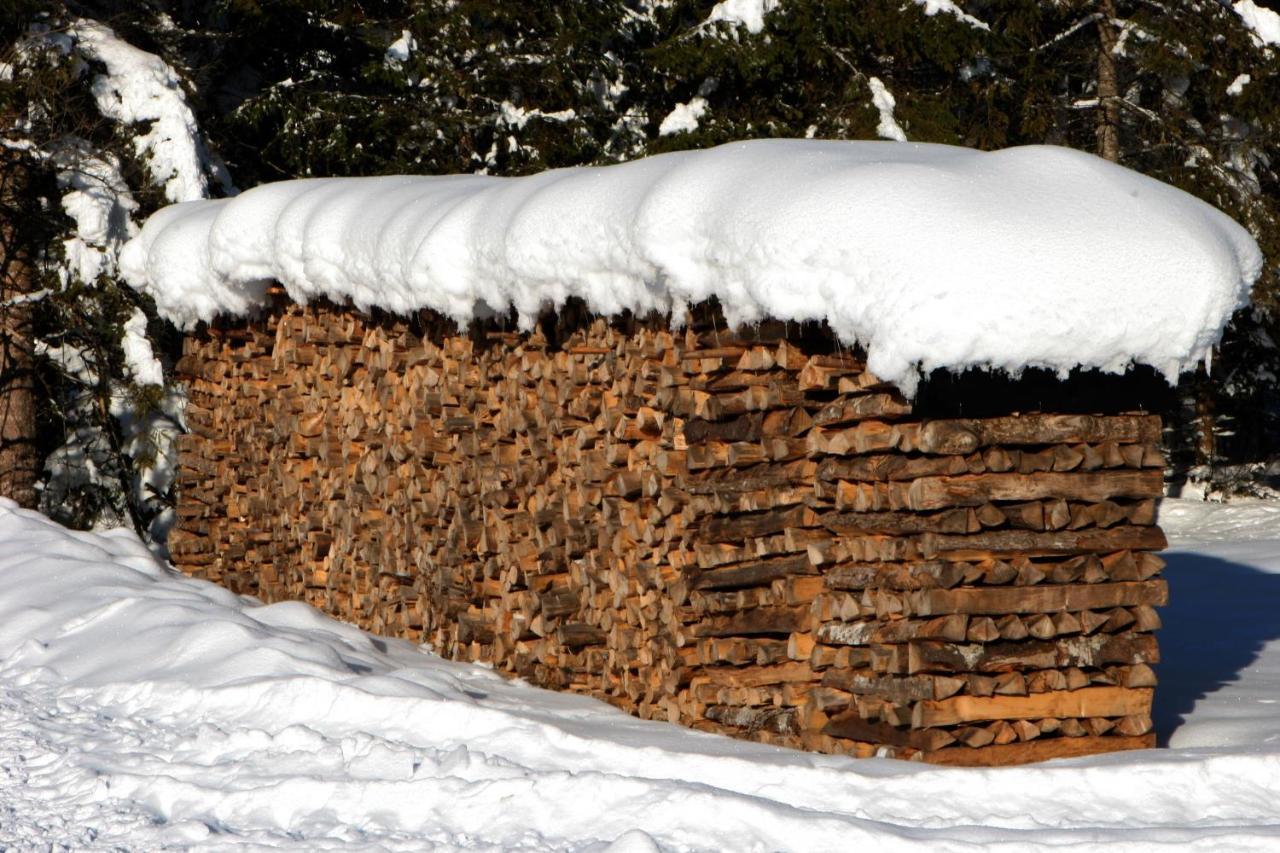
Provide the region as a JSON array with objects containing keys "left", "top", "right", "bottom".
[{"left": 0, "top": 491, "right": 1280, "bottom": 852}]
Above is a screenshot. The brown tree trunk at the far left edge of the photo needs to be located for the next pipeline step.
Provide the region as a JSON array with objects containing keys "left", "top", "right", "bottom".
[{"left": 0, "top": 150, "right": 40, "bottom": 507}]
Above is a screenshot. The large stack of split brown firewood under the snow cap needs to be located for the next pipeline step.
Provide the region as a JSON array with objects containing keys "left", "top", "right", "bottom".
[{"left": 170, "top": 294, "right": 1166, "bottom": 765}]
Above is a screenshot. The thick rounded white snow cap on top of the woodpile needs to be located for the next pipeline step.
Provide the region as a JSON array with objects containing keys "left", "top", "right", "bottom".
[{"left": 120, "top": 140, "right": 1262, "bottom": 392}]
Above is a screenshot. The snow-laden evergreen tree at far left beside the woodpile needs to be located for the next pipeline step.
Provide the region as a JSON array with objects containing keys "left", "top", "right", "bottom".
[{"left": 0, "top": 6, "right": 220, "bottom": 539}]
